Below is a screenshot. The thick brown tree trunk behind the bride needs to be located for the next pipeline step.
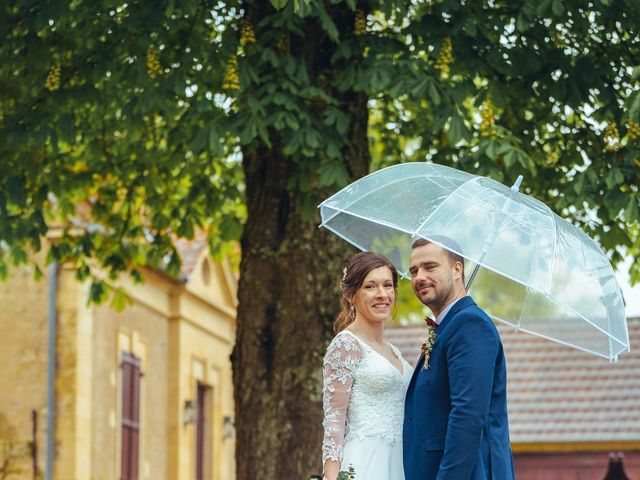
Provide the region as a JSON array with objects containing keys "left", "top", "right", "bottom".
[{"left": 233, "top": 3, "right": 369, "bottom": 480}]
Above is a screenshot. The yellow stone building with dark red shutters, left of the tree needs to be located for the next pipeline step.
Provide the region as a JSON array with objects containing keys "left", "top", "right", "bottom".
[{"left": 0, "top": 237, "right": 236, "bottom": 480}]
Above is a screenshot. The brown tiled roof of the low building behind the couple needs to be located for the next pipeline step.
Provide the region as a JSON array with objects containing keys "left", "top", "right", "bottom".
[{"left": 386, "top": 318, "right": 640, "bottom": 444}]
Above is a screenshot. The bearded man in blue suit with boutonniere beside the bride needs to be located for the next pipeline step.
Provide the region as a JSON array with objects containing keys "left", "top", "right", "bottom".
[{"left": 403, "top": 237, "right": 514, "bottom": 480}]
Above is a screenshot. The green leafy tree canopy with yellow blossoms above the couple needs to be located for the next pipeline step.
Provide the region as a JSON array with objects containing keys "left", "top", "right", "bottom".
[{"left": 0, "top": 0, "right": 640, "bottom": 478}]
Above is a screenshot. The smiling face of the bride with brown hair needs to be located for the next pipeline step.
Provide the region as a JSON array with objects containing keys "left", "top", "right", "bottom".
[{"left": 353, "top": 267, "right": 396, "bottom": 322}]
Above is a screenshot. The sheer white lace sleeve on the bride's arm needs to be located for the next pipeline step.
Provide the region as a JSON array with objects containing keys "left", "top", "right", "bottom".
[{"left": 322, "top": 333, "right": 362, "bottom": 464}]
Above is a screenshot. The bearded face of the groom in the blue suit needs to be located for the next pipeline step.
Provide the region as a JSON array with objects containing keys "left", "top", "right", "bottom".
[{"left": 409, "top": 243, "right": 456, "bottom": 312}]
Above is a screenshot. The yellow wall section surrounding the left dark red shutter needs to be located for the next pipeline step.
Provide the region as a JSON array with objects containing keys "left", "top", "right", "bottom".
[{"left": 91, "top": 301, "right": 169, "bottom": 480}]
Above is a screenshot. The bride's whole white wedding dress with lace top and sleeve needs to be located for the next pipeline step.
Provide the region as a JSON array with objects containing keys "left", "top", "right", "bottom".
[{"left": 322, "top": 329, "right": 413, "bottom": 480}]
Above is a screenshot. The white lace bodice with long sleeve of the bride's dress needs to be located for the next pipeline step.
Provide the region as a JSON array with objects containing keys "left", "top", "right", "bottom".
[{"left": 322, "top": 330, "right": 413, "bottom": 463}]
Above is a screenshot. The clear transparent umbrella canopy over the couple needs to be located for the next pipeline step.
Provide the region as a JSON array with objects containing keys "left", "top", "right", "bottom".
[{"left": 320, "top": 162, "right": 629, "bottom": 361}]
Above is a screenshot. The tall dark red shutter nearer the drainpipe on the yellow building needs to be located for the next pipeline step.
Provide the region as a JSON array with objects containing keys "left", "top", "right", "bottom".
[{"left": 120, "top": 352, "right": 140, "bottom": 480}]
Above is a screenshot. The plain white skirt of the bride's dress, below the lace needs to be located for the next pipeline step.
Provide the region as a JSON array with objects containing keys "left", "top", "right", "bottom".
[{"left": 340, "top": 437, "right": 404, "bottom": 480}]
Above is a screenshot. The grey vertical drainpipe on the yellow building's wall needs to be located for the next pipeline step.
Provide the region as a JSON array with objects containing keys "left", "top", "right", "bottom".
[{"left": 45, "top": 262, "right": 58, "bottom": 480}]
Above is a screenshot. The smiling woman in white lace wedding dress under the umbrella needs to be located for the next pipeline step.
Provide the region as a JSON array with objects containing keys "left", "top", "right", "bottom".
[{"left": 322, "top": 252, "right": 413, "bottom": 480}]
